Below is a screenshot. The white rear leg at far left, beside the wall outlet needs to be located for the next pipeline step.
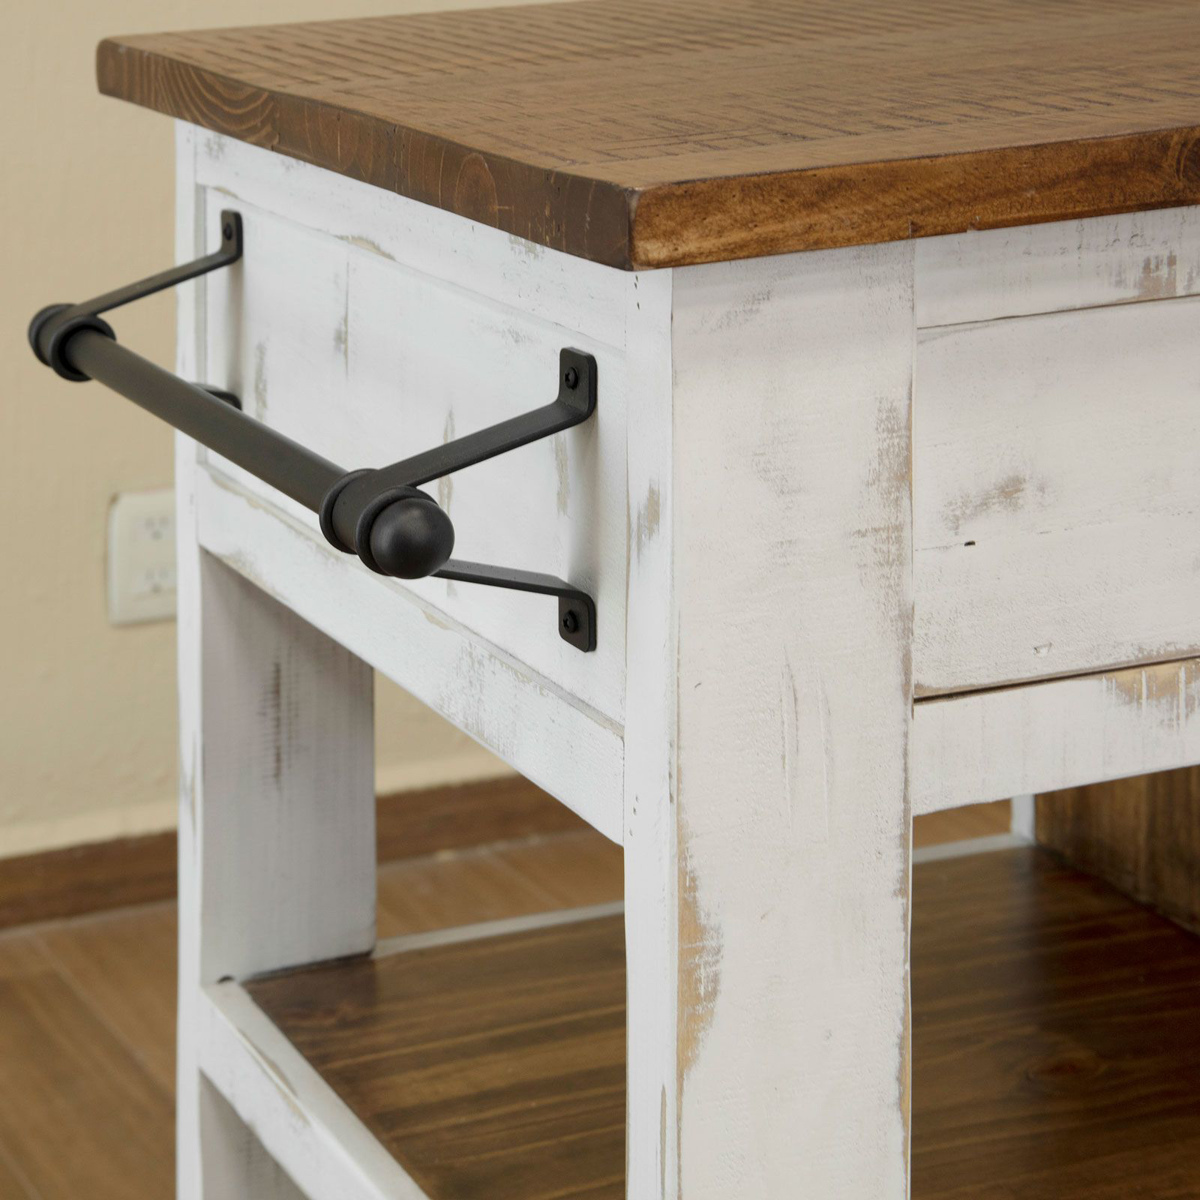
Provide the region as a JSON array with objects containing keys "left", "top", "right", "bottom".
[{"left": 176, "top": 438, "right": 374, "bottom": 1200}]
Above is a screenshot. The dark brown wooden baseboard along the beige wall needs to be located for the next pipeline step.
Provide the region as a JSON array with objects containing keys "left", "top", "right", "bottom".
[{"left": 0, "top": 775, "right": 588, "bottom": 929}]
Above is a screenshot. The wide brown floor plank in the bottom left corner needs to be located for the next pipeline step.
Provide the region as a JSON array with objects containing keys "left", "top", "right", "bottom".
[{"left": 0, "top": 936, "right": 174, "bottom": 1200}]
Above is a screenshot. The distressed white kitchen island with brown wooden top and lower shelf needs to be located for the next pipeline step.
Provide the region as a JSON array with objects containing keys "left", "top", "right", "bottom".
[{"left": 23, "top": 0, "right": 1200, "bottom": 1200}]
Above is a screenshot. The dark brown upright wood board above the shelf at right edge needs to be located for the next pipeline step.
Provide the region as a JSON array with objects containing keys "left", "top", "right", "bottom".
[{"left": 1037, "top": 767, "right": 1200, "bottom": 932}]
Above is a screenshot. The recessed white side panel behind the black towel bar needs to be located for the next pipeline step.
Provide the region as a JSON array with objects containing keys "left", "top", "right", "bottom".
[{"left": 202, "top": 188, "right": 628, "bottom": 724}]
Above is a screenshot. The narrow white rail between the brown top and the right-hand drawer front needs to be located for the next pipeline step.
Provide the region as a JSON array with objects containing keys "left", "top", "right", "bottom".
[{"left": 916, "top": 208, "right": 1200, "bottom": 326}]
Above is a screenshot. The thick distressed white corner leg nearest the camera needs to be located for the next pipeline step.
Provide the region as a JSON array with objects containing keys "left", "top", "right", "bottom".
[{"left": 625, "top": 245, "right": 912, "bottom": 1200}]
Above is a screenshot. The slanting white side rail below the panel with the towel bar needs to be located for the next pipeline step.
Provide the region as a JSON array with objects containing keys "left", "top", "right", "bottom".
[{"left": 197, "top": 472, "right": 624, "bottom": 841}]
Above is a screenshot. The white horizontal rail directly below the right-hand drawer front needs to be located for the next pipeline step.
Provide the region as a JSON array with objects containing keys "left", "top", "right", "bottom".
[{"left": 912, "top": 659, "right": 1200, "bottom": 814}]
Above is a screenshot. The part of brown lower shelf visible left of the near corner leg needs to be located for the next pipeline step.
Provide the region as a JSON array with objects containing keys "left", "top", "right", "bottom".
[{"left": 248, "top": 917, "right": 625, "bottom": 1200}]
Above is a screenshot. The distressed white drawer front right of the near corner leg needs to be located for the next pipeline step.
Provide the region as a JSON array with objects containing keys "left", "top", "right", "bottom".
[{"left": 913, "top": 291, "right": 1200, "bottom": 696}]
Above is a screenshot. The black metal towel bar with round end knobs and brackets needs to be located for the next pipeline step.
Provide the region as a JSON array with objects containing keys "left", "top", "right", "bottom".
[{"left": 29, "top": 211, "right": 596, "bottom": 650}]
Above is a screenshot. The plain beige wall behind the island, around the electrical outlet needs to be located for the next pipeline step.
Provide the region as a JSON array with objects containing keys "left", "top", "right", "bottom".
[{"left": 0, "top": 0, "right": 503, "bottom": 857}]
